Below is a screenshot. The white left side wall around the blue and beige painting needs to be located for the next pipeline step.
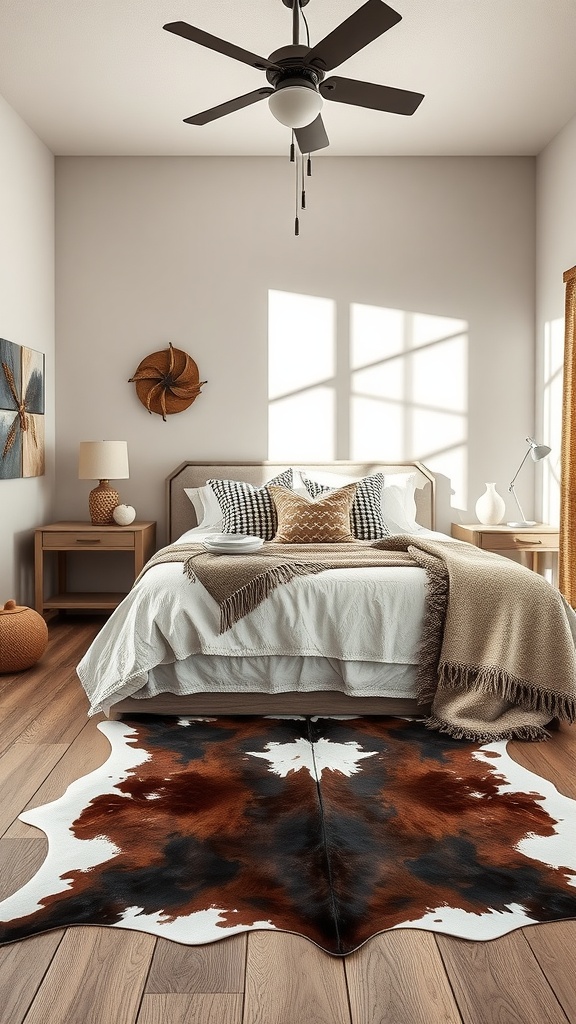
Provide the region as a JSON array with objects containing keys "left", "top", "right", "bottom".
[{"left": 0, "top": 96, "right": 54, "bottom": 606}]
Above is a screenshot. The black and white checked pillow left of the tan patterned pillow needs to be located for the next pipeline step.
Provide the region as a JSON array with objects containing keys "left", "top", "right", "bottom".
[{"left": 206, "top": 469, "right": 293, "bottom": 541}]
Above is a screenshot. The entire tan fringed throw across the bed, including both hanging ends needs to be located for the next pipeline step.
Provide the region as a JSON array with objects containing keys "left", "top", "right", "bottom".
[{"left": 135, "top": 536, "right": 576, "bottom": 742}]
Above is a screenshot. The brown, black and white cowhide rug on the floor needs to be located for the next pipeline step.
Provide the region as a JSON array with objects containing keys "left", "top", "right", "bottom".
[{"left": 0, "top": 716, "right": 576, "bottom": 954}]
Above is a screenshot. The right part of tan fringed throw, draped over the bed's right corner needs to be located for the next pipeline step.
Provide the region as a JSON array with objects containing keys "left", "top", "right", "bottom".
[{"left": 378, "top": 537, "right": 576, "bottom": 742}]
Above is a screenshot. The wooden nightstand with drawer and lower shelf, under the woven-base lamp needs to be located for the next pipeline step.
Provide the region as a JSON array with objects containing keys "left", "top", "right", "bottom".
[{"left": 34, "top": 522, "right": 156, "bottom": 615}]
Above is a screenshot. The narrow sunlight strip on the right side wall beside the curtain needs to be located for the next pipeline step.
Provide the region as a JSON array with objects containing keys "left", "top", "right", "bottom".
[{"left": 542, "top": 317, "right": 564, "bottom": 524}]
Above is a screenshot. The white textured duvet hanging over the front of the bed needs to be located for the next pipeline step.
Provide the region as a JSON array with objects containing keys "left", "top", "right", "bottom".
[{"left": 77, "top": 529, "right": 453, "bottom": 714}]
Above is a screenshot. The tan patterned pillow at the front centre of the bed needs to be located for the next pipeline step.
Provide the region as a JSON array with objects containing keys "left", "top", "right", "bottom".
[{"left": 269, "top": 483, "right": 357, "bottom": 544}]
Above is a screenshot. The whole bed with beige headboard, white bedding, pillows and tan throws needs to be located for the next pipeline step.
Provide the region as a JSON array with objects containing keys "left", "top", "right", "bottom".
[{"left": 77, "top": 462, "right": 576, "bottom": 738}]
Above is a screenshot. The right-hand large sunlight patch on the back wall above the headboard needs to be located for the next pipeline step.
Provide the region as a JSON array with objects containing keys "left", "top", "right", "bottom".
[{"left": 349, "top": 303, "right": 467, "bottom": 508}]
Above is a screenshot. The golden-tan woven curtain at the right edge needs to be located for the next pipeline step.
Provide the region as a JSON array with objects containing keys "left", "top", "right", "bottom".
[{"left": 559, "top": 266, "right": 576, "bottom": 607}]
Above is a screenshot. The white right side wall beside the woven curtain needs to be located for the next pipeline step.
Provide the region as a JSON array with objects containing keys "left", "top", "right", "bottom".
[{"left": 536, "top": 111, "right": 576, "bottom": 523}]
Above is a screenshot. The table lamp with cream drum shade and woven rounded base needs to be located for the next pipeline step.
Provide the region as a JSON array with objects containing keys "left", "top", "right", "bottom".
[{"left": 78, "top": 441, "right": 130, "bottom": 526}]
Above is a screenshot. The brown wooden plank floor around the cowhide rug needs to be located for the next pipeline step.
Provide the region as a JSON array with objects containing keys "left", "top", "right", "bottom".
[{"left": 0, "top": 618, "right": 576, "bottom": 1024}]
